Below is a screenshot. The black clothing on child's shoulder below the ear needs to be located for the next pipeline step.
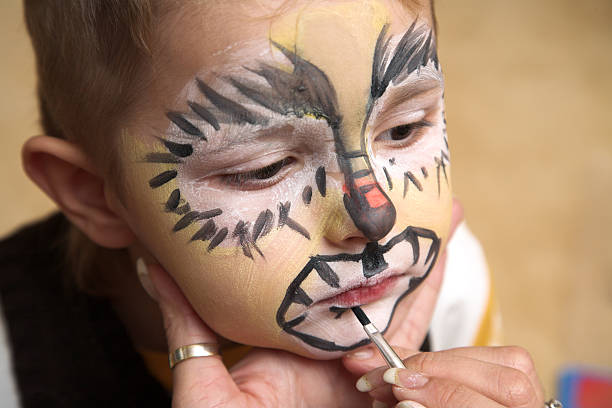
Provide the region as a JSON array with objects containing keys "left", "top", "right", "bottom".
[{"left": 0, "top": 214, "right": 170, "bottom": 408}]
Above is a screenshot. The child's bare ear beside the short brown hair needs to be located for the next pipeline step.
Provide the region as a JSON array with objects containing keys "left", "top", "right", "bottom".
[{"left": 22, "top": 136, "right": 135, "bottom": 248}]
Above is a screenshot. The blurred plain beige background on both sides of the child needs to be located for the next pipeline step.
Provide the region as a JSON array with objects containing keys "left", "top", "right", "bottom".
[{"left": 0, "top": 0, "right": 612, "bottom": 394}]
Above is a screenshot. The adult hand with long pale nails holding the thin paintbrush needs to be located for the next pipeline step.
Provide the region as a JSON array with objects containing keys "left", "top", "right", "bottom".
[{"left": 357, "top": 347, "right": 544, "bottom": 408}]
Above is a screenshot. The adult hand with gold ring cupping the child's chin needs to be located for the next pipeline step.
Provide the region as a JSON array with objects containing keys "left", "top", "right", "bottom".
[{"left": 146, "top": 264, "right": 371, "bottom": 408}]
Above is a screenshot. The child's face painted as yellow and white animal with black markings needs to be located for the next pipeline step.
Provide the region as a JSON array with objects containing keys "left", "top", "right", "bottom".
[{"left": 120, "top": 0, "right": 451, "bottom": 358}]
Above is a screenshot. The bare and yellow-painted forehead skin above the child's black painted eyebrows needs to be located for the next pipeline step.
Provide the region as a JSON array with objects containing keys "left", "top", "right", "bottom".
[{"left": 165, "top": 0, "right": 436, "bottom": 114}]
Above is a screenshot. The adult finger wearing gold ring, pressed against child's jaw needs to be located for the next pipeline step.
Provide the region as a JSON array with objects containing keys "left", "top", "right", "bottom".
[{"left": 146, "top": 261, "right": 241, "bottom": 408}]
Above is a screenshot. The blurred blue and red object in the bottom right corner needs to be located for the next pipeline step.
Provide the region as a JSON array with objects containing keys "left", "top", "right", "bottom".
[{"left": 558, "top": 367, "right": 612, "bottom": 408}]
